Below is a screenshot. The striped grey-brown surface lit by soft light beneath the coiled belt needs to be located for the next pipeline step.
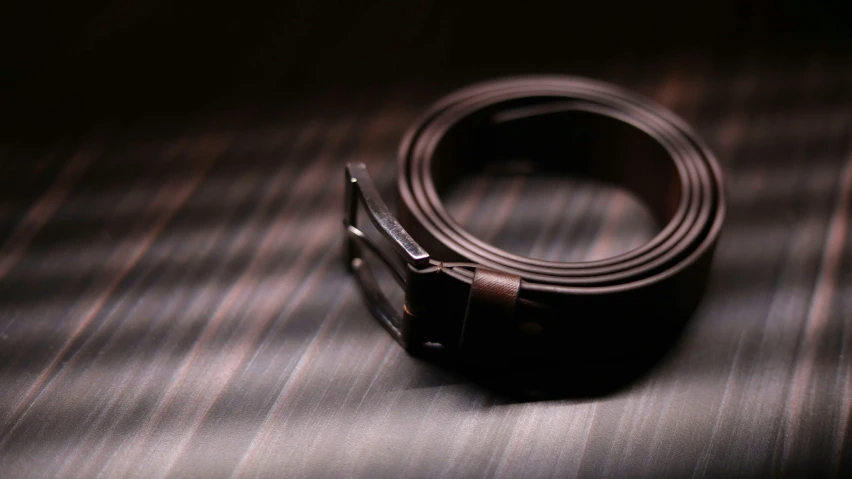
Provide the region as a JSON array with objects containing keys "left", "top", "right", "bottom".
[{"left": 0, "top": 56, "right": 852, "bottom": 478}]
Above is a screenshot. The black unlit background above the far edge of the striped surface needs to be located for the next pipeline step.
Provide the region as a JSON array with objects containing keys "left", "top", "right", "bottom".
[{"left": 0, "top": 0, "right": 852, "bottom": 132}]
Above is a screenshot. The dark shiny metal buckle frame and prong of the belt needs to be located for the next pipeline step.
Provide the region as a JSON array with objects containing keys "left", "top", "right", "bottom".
[{"left": 343, "top": 162, "right": 431, "bottom": 349}]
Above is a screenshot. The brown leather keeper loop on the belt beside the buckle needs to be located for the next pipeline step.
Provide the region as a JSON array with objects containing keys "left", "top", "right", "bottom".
[{"left": 459, "top": 268, "right": 521, "bottom": 353}]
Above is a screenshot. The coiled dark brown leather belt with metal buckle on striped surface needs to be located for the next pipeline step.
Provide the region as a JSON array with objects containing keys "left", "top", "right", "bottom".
[{"left": 344, "top": 77, "right": 725, "bottom": 364}]
